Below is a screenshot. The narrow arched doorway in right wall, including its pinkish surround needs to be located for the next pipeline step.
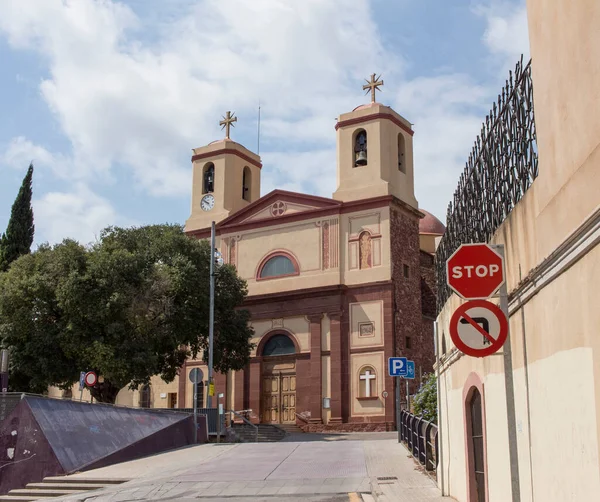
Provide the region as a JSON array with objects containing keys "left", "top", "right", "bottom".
[{"left": 463, "top": 373, "right": 489, "bottom": 502}]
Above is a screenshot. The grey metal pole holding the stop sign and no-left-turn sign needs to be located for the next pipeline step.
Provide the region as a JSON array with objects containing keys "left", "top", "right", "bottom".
[{"left": 494, "top": 244, "right": 521, "bottom": 502}]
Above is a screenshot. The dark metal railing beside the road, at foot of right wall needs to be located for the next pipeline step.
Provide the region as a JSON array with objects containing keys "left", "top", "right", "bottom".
[{"left": 400, "top": 411, "right": 439, "bottom": 471}]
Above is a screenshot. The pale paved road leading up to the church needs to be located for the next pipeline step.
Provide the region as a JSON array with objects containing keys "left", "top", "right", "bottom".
[{"left": 55, "top": 433, "right": 447, "bottom": 502}]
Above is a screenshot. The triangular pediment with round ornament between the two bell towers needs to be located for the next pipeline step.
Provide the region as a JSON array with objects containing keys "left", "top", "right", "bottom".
[{"left": 217, "top": 190, "right": 342, "bottom": 227}]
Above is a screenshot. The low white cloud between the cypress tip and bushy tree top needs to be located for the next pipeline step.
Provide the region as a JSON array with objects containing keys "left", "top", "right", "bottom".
[{"left": 33, "top": 183, "right": 130, "bottom": 244}]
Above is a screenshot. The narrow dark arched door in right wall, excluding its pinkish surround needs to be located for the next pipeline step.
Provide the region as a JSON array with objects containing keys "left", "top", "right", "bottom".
[{"left": 465, "top": 387, "right": 486, "bottom": 502}]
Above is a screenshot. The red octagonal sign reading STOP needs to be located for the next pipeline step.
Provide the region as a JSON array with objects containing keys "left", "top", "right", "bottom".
[{"left": 446, "top": 244, "right": 504, "bottom": 300}]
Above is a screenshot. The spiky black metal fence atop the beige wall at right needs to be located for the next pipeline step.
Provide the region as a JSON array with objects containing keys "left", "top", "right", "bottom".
[{"left": 436, "top": 56, "right": 538, "bottom": 313}]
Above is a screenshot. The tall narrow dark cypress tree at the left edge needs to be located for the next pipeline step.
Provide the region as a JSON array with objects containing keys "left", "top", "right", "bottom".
[{"left": 0, "top": 164, "right": 34, "bottom": 271}]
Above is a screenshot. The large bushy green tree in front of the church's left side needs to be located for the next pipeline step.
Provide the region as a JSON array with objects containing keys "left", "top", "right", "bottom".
[{"left": 0, "top": 225, "right": 253, "bottom": 402}]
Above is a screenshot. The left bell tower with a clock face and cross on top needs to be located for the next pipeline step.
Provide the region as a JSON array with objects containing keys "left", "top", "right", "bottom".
[{"left": 185, "top": 112, "right": 262, "bottom": 232}]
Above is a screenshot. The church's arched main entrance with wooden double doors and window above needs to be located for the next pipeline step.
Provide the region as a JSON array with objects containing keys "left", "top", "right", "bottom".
[{"left": 260, "top": 333, "right": 296, "bottom": 424}]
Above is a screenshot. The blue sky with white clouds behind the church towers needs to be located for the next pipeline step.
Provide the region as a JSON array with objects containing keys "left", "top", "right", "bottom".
[{"left": 0, "top": 0, "right": 529, "bottom": 244}]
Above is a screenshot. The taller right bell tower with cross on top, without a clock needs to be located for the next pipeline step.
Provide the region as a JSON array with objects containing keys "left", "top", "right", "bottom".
[{"left": 333, "top": 74, "right": 418, "bottom": 208}]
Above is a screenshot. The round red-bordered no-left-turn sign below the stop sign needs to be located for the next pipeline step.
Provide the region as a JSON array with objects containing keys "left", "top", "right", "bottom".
[{"left": 450, "top": 300, "right": 508, "bottom": 357}]
